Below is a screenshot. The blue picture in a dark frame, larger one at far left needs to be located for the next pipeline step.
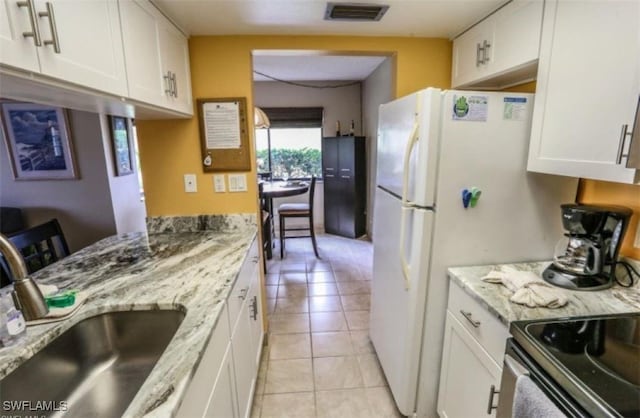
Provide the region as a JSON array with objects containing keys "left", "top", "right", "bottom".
[{"left": 2, "top": 102, "right": 78, "bottom": 180}]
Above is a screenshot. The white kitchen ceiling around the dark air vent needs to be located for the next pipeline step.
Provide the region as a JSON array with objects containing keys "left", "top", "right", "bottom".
[{"left": 154, "top": 0, "right": 506, "bottom": 38}]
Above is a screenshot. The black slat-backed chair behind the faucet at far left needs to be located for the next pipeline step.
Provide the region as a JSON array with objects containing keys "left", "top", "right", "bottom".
[{"left": 0, "top": 218, "right": 71, "bottom": 281}]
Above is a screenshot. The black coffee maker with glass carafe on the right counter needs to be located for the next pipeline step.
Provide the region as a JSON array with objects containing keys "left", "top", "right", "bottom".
[{"left": 542, "top": 204, "right": 633, "bottom": 290}]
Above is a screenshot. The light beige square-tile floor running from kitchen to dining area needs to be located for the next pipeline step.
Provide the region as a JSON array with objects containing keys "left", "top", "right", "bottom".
[{"left": 252, "top": 235, "right": 402, "bottom": 418}]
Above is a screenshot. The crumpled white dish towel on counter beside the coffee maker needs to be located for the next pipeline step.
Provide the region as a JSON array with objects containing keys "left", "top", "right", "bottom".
[{"left": 482, "top": 266, "right": 567, "bottom": 308}]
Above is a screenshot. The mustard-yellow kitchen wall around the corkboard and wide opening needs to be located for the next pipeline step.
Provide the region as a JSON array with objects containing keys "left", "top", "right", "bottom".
[{"left": 136, "top": 36, "right": 451, "bottom": 216}]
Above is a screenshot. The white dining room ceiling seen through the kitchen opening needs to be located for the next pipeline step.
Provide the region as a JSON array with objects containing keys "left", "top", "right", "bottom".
[{"left": 253, "top": 54, "right": 386, "bottom": 81}]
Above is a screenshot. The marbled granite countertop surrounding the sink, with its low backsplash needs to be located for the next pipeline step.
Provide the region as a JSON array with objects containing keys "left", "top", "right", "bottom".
[{"left": 0, "top": 215, "right": 257, "bottom": 417}]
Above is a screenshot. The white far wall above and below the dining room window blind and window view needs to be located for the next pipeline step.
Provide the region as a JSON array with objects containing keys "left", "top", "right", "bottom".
[{"left": 253, "top": 81, "right": 362, "bottom": 231}]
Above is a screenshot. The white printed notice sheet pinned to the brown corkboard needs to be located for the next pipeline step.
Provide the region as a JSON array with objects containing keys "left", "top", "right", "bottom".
[{"left": 202, "top": 102, "right": 240, "bottom": 149}]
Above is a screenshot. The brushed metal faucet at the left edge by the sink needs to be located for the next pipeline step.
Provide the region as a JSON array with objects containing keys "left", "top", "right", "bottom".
[{"left": 0, "top": 234, "right": 49, "bottom": 321}]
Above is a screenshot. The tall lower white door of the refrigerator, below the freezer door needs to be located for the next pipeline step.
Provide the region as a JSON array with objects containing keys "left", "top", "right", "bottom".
[{"left": 369, "top": 188, "right": 434, "bottom": 415}]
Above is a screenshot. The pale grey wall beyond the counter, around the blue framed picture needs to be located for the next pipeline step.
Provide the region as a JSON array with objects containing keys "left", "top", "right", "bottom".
[{"left": 0, "top": 110, "right": 145, "bottom": 251}]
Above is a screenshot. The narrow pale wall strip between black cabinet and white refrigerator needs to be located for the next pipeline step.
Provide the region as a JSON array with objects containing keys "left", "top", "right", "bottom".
[{"left": 362, "top": 58, "right": 394, "bottom": 238}]
